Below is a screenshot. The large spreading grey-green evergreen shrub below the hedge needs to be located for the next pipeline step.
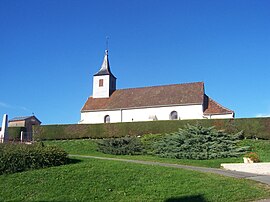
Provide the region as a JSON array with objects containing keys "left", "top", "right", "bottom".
[{"left": 153, "top": 125, "right": 248, "bottom": 159}]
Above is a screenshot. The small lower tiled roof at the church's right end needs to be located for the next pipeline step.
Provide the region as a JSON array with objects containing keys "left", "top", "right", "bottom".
[{"left": 204, "top": 95, "right": 234, "bottom": 115}]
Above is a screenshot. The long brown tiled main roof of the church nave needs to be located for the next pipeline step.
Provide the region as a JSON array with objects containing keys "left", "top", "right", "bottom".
[{"left": 82, "top": 82, "right": 204, "bottom": 112}]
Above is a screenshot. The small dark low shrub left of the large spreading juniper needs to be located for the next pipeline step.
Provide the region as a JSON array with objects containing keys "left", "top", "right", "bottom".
[{"left": 97, "top": 137, "right": 143, "bottom": 155}]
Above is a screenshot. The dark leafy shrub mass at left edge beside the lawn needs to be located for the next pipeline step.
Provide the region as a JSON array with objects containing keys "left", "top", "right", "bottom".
[{"left": 0, "top": 143, "right": 68, "bottom": 174}]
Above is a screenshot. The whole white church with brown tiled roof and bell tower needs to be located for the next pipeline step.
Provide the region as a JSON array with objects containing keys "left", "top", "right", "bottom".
[{"left": 79, "top": 50, "right": 234, "bottom": 124}]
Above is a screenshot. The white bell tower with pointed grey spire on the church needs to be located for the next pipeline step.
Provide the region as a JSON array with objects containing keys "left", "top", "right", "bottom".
[{"left": 93, "top": 50, "right": 116, "bottom": 98}]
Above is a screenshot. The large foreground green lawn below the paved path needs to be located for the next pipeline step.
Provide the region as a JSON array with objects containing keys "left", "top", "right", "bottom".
[{"left": 0, "top": 159, "right": 270, "bottom": 202}]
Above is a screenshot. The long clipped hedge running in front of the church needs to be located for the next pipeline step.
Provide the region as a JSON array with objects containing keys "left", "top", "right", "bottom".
[{"left": 33, "top": 118, "right": 270, "bottom": 140}]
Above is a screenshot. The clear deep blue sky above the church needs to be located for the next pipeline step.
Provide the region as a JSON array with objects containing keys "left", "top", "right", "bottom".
[{"left": 0, "top": 0, "right": 270, "bottom": 124}]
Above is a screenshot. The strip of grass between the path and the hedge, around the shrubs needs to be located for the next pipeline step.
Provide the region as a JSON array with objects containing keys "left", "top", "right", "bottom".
[{"left": 45, "top": 139, "right": 270, "bottom": 168}]
